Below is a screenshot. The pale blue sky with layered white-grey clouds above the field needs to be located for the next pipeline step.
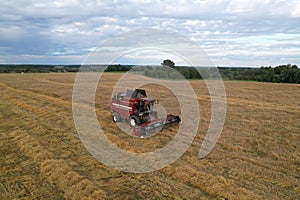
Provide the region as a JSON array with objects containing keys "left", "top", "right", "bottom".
[{"left": 0, "top": 0, "right": 300, "bottom": 67}]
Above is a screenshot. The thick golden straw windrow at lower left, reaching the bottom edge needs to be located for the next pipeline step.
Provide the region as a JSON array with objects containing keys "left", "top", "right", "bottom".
[{"left": 9, "top": 131, "right": 106, "bottom": 199}]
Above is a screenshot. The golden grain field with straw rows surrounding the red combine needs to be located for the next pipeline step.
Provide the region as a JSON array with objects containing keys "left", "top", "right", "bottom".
[{"left": 0, "top": 73, "right": 300, "bottom": 199}]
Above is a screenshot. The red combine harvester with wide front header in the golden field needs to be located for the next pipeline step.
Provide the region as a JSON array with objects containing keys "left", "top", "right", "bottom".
[{"left": 111, "top": 89, "right": 180, "bottom": 138}]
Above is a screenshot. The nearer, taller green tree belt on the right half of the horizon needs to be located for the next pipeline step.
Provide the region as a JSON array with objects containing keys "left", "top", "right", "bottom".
[{"left": 135, "top": 60, "right": 300, "bottom": 83}]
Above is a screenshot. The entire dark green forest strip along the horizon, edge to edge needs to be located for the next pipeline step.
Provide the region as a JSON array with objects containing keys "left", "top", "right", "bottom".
[{"left": 0, "top": 63, "right": 300, "bottom": 84}]
